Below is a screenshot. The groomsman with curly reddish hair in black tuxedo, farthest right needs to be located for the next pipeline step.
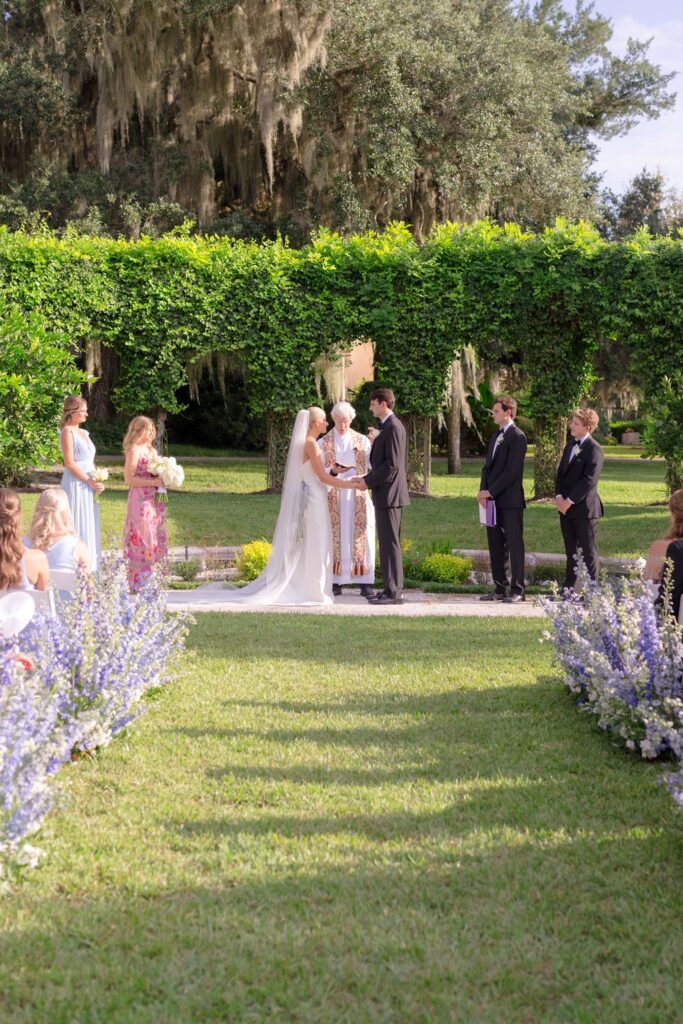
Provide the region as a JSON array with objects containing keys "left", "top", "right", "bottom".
[{"left": 555, "top": 409, "right": 604, "bottom": 590}]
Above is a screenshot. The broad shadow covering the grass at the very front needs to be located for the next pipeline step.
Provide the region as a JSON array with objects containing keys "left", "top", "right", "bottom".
[{"left": 0, "top": 820, "right": 683, "bottom": 1024}]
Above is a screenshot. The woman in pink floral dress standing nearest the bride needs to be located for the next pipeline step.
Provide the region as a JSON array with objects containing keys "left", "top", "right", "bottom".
[{"left": 123, "top": 416, "right": 168, "bottom": 593}]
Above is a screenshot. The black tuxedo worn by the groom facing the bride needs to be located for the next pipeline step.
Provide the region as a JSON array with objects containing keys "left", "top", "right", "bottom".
[{"left": 365, "top": 415, "right": 411, "bottom": 597}]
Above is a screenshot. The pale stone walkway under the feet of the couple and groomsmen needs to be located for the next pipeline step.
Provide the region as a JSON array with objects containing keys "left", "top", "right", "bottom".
[{"left": 166, "top": 583, "right": 545, "bottom": 618}]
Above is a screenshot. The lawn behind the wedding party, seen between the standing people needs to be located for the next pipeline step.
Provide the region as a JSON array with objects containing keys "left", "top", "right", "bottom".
[{"left": 22, "top": 459, "right": 668, "bottom": 557}]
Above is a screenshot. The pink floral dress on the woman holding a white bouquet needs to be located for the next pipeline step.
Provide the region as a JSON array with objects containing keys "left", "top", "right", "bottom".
[{"left": 123, "top": 456, "right": 168, "bottom": 591}]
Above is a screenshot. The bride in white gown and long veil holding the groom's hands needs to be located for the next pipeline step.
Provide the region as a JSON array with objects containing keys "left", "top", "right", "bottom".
[{"left": 223, "top": 406, "right": 355, "bottom": 604}]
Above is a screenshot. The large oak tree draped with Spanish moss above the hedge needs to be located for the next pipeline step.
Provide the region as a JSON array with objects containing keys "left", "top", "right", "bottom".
[{"left": 0, "top": 0, "right": 673, "bottom": 242}]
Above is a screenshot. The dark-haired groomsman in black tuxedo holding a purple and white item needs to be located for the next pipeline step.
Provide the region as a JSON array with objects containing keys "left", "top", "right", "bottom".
[{"left": 477, "top": 395, "right": 526, "bottom": 604}]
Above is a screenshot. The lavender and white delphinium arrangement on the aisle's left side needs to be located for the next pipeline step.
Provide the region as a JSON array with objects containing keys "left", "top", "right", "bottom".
[{"left": 0, "top": 557, "right": 186, "bottom": 877}]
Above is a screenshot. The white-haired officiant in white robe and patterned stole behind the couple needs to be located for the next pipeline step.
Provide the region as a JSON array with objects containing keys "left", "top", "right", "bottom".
[{"left": 318, "top": 401, "right": 375, "bottom": 597}]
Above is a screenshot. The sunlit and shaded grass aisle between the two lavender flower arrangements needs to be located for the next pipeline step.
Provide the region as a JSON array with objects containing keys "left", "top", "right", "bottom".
[{"left": 0, "top": 614, "right": 683, "bottom": 1024}]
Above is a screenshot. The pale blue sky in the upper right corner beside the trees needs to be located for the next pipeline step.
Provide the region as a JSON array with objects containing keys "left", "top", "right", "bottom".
[{"left": 589, "top": 0, "right": 683, "bottom": 193}]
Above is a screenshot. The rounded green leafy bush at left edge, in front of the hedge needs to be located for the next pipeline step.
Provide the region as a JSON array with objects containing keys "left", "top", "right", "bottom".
[{"left": 0, "top": 303, "right": 87, "bottom": 486}]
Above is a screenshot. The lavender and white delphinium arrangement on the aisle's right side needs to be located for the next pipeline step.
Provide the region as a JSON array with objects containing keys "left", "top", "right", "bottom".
[{"left": 542, "top": 562, "right": 683, "bottom": 805}]
